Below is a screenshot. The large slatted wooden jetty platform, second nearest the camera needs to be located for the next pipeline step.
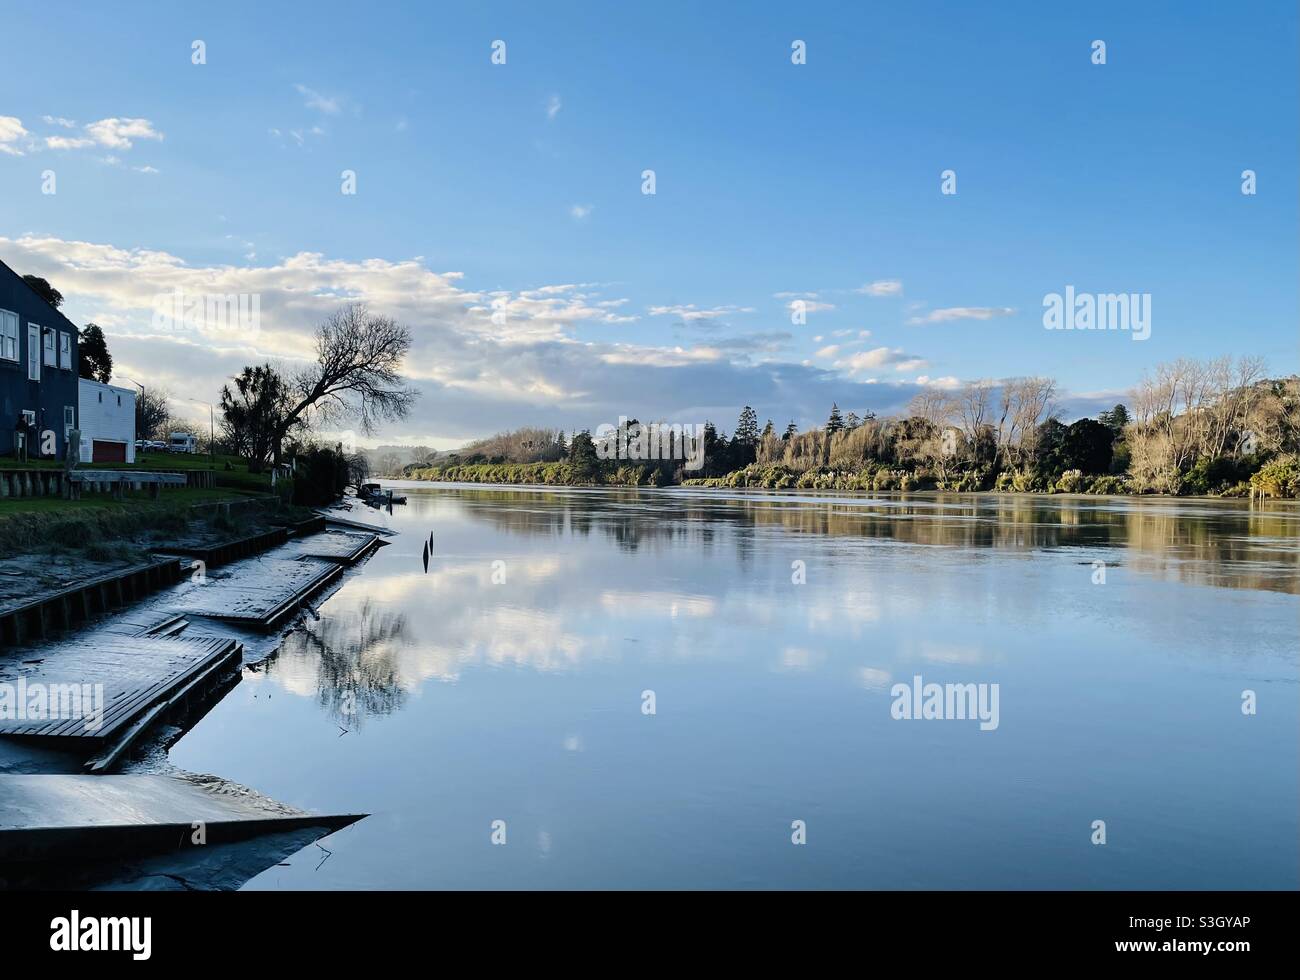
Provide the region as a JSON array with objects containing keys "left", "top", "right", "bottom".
[{"left": 0, "top": 620, "right": 243, "bottom": 772}]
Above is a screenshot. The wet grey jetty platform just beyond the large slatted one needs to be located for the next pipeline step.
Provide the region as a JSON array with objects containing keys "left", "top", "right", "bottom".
[{"left": 170, "top": 555, "right": 343, "bottom": 629}]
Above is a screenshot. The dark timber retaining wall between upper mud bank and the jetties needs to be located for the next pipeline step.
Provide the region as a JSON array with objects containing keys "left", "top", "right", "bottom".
[{"left": 0, "top": 558, "right": 185, "bottom": 647}]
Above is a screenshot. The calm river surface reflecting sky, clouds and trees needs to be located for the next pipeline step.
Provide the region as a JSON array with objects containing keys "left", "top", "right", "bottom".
[{"left": 172, "top": 485, "right": 1300, "bottom": 889}]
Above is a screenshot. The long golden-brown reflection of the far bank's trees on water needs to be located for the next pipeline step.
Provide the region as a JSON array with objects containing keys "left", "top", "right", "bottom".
[{"left": 441, "top": 490, "right": 1300, "bottom": 594}]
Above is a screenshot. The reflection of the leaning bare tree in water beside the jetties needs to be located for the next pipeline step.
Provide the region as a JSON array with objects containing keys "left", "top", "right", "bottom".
[{"left": 267, "top": 599, "right": 408, "bottom": 728}]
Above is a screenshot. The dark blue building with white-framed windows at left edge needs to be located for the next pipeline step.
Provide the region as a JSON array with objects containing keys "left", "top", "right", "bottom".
[{"left": 0, "top": 263, "right": 78, "bottom": 459}]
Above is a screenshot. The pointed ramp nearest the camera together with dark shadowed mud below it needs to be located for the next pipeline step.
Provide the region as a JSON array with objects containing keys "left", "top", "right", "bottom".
[{"left": 0, "top": 773, "right": 365, "bottom": 888}]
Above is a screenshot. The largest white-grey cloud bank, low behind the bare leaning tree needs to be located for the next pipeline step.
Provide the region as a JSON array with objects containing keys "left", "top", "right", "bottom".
[{"left": 0, "top": 237, "right": 951, "bottom": 445}]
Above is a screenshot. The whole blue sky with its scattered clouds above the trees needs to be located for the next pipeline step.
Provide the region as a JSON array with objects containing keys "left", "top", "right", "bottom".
[{"left": 0, "top": 3, "right": 1300, "bottom": 447}]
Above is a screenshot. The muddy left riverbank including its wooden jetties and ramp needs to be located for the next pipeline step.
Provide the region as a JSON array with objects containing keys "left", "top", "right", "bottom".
[{"left": 0, "top": 496, "right": 382, "bottom": 889}]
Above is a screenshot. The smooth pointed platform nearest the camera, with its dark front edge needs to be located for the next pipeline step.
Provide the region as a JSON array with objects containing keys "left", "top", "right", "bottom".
[{"left": 0, "top": 773, "right": 367, "bottom": 866}]
